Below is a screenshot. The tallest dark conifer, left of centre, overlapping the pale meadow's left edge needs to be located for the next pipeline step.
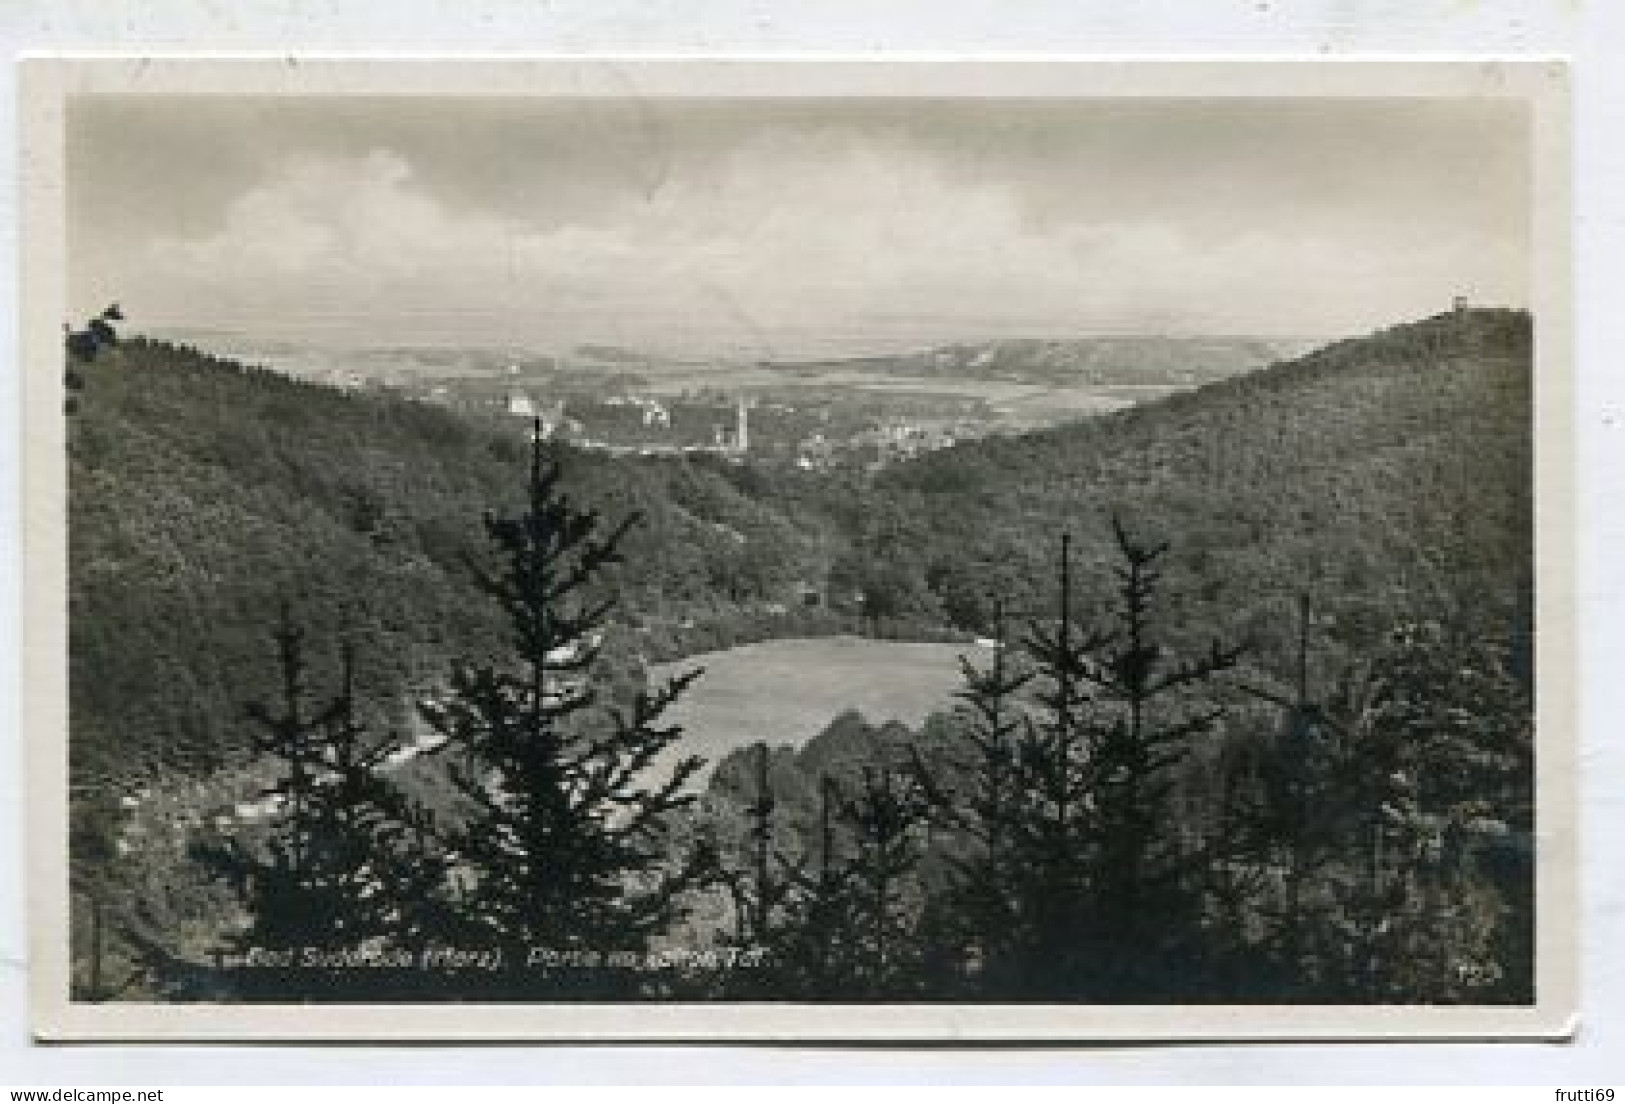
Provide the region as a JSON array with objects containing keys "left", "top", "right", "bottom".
[{"left": 421, "top": 424, "right": 713, "bottom": 992}]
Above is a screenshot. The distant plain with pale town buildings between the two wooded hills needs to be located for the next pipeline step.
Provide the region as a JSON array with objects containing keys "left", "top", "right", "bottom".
[{"left": 177, "top": 337, "right": 1297, "bottom": 472}]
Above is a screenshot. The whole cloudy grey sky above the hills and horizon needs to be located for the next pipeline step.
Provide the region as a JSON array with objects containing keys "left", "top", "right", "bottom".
[{"left": 68, "top": 98, "right": 1529, "bottom": 356}]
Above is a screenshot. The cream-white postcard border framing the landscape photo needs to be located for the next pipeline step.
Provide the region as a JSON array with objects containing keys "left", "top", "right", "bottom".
[{"left": 18, "top": 54, "right": 1580, "bottom": 1044}]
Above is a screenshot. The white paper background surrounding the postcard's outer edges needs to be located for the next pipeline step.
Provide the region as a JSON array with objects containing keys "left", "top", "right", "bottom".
[{"left": 0, "top": 0, "right": 1625, "bottom": 1088}]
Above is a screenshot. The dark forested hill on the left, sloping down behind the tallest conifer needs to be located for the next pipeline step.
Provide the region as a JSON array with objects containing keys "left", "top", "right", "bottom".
[{"left": 70, "top": 340, "right": 835, "bottom": 779}]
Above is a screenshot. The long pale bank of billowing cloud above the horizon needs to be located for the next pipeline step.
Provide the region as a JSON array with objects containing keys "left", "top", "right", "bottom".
[{"left": 93, "top": 128, "right": 1524, "bottom": 354}]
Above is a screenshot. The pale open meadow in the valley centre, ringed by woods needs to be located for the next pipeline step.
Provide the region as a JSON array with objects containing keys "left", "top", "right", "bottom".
[{"left": 655, "top": 636, "right": 985, "bottom": 780}]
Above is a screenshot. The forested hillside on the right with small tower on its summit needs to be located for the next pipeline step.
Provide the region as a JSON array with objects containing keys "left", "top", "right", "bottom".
[{"left": 852, "top": 311, "right": 1532, "bottom": 679}]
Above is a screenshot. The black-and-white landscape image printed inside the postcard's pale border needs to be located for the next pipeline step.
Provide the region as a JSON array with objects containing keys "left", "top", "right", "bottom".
[{"left": 29, "top": 63, "right": 1573, "bottom": 1036}]
